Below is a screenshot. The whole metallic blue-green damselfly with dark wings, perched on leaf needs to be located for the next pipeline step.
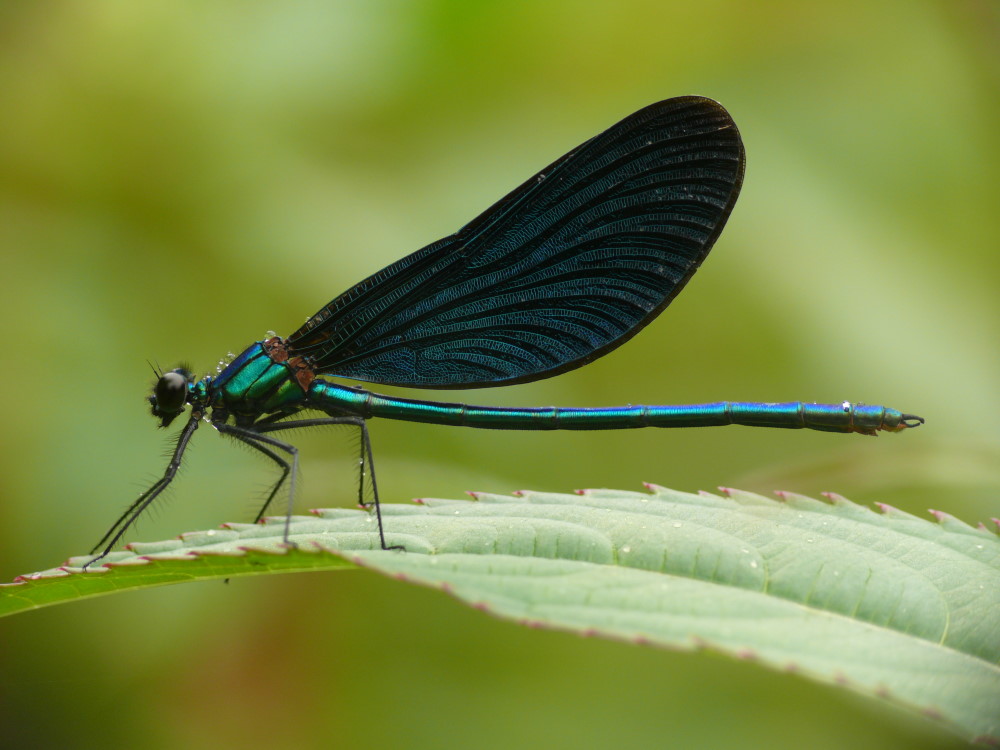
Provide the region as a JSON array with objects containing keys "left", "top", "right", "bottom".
[{"left": 91, "top": 97, "right": 923, "bottom": 564}]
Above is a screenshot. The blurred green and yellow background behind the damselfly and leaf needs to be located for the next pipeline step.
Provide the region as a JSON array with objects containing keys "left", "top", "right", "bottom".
[{"left": 0, "top": 0, "right": 1000, "bottom": 748}]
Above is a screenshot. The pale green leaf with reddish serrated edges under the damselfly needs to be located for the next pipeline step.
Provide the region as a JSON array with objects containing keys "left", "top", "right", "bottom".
[{"left": 0, "top": 488, "right": 1000, "bottom": 743}]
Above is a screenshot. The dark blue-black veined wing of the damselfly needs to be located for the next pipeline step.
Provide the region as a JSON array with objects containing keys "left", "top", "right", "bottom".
[{"left": 288, "top": 97, "right": 744, "bottom": 388}]
